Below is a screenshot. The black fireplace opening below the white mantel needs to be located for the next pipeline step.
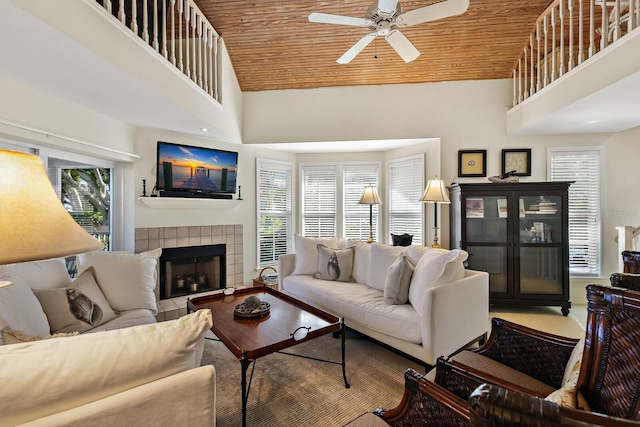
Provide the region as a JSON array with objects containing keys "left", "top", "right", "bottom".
[{"left": 160, "top": 244, "right": 227, "bottom": 300}]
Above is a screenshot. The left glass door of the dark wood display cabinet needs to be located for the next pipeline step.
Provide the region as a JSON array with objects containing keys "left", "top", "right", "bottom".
[{"left": 462, "top": 196, "right": 509, "bottom": 293}]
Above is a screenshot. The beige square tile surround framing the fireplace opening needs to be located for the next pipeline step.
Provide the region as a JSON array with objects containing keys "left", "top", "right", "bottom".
[{"left": 135, "top": 224, "right": 244, "bottom": 321}]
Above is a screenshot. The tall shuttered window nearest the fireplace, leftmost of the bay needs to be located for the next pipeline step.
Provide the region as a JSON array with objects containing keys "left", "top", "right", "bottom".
[{"left": 256, "top": 159, "right": 293, "bottom": 268}]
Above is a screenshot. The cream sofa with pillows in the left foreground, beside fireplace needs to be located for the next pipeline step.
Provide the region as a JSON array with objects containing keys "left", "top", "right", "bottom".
[{"left": 0, "top": 251, "right": 216, "bottom": 426}]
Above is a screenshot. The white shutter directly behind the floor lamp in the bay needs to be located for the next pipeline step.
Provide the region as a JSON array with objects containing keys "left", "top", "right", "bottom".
[{"left": 342, "top": 164, "right": 380, "bottom": 241}]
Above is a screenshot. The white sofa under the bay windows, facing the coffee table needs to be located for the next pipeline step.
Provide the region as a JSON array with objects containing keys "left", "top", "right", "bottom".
[{"left": 278, "top": 236, "right": 490, "bottom": 365}]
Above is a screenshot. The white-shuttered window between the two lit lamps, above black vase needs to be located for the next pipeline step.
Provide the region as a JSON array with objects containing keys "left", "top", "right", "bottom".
[{"left": 387, "top": 155, "right": 424, "bottom": 245}]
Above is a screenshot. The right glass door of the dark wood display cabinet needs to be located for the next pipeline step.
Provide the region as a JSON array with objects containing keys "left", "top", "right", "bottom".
[{"left": 516, "top": 195, "right": 563, "bottom": 296}]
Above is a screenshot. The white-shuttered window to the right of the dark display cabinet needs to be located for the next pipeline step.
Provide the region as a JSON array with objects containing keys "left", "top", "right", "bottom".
[{"left": 549, "top": 148, "right": 601, "bottom": 276}]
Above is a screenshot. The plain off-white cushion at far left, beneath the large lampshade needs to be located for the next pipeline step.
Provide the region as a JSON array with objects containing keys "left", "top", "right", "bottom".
[{"left": 0, "top": 273, "right": 51, "bottom": 342}]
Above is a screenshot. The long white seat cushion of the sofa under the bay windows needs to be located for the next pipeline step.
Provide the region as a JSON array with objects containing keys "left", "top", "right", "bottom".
[{"left": 283, "top": 276, "right": 422, "bottom": 344}]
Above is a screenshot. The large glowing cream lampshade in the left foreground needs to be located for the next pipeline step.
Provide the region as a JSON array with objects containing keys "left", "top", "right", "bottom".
[{"left": 0, "top": 150, "right": 104, "bottom": 265}]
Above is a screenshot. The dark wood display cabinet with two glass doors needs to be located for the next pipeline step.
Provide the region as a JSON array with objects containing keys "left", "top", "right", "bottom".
[{"left": 449, "top": 182, "right": 571, "bottom": 316}]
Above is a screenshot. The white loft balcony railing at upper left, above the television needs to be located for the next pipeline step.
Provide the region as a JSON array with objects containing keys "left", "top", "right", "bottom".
[{"left": 96, "top": 0, "right": 221, "bottom": 102}]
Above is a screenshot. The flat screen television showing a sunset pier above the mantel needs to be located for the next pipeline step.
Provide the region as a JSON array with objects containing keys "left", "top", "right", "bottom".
[{"left": 156, "top": 141, "right": 238, "bottom": 199}]
